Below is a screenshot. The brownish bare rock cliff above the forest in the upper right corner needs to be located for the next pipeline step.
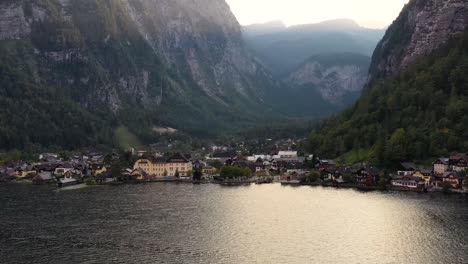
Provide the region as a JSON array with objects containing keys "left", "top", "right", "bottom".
[{"left": 370, "top": 0, "right": 468, "bottom": 80}]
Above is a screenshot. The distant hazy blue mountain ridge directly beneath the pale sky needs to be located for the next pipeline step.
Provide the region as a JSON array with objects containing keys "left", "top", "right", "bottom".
[{"left": 244, "top": 19, "right": 384, "bottom": 76}]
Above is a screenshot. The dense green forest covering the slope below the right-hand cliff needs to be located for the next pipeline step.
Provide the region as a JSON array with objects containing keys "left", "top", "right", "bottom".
[{"left": 310, "top": 34, "right": 468, "bottom": 167}]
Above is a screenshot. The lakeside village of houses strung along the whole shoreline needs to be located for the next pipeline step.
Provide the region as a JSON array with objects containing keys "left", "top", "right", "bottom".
[{"left": 0, "top": 147, "right": 468, "bottom": 193}]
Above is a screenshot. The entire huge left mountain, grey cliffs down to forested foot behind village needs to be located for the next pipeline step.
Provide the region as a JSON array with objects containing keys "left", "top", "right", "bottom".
[{"left": 0, "top": 0, "right": 276, "bottom": 149}]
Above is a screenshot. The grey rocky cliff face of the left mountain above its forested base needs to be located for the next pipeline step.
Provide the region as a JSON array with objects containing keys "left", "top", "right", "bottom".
[{"left": 0, "top": 0, "right": 274, "bottom": 147}]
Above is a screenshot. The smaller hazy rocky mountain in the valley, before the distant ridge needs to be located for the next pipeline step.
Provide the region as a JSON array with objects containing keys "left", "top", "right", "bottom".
[{"left": 285, "top": 53, "right": 370, "bottom": 106}]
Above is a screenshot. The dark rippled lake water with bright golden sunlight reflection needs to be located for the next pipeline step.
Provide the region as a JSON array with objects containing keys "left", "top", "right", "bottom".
[{"left": 0, "top": 183, "right": 468, "bottom": 264}]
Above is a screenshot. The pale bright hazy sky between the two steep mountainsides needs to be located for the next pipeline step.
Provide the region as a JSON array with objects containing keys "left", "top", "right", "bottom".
[{"left": 226, "top": 0, "right": 408, "bottom": 28}]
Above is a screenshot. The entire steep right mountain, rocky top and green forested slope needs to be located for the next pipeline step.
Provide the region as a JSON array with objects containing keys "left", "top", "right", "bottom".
[{"left": 310, "top": 0, "right": 468, "bottom": 167}]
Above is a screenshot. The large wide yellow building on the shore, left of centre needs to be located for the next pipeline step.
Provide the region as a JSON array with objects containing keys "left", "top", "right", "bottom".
[{"left": 133, "top": 154, "right": 192, "bottom": 177}]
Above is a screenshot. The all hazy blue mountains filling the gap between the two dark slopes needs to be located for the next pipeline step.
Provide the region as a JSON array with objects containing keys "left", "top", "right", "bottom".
[{"left": 243, "top": 19, "right": 385, "bottom": 111}]
